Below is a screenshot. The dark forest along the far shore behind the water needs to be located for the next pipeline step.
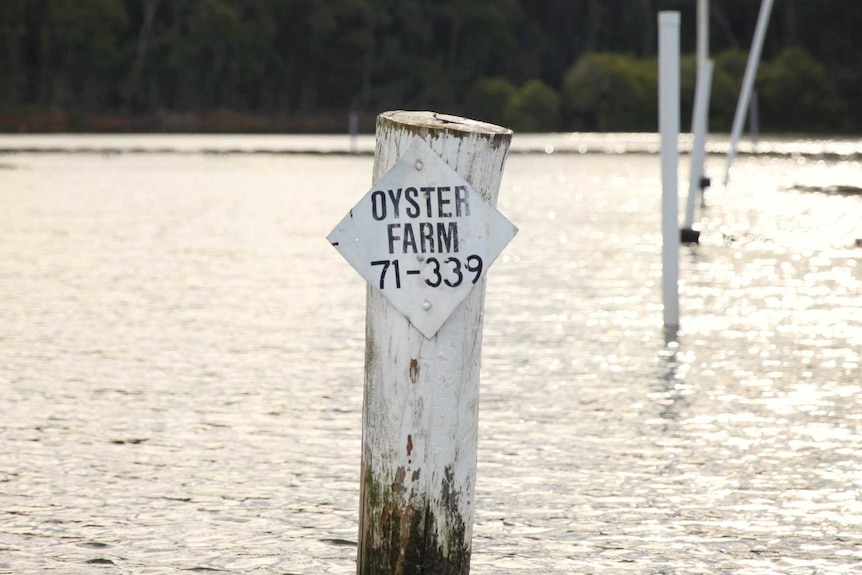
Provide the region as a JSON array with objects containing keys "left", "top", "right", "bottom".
[{"left": 0, "top": 0, "right": 862, "bottom": 134}]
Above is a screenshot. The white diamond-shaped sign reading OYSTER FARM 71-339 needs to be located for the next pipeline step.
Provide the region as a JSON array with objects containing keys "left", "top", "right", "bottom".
[{"left": 327, "top": 136, "right": 518, "bottom": 339}]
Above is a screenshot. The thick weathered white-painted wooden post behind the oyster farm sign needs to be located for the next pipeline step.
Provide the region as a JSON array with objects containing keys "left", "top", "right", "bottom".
[{"left": 357, "top": 111, "right": 512, "bottom": 575}]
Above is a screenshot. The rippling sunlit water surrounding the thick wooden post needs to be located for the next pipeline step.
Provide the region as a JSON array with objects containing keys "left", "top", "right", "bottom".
[{"left": 0, "top": 136, "right": 862, "bottom": 575}]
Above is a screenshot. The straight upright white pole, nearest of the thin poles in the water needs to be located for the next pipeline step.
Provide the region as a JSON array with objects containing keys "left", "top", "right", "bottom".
[{"left": 658, "top": 12, "right": 680, "bottom": 326}]
